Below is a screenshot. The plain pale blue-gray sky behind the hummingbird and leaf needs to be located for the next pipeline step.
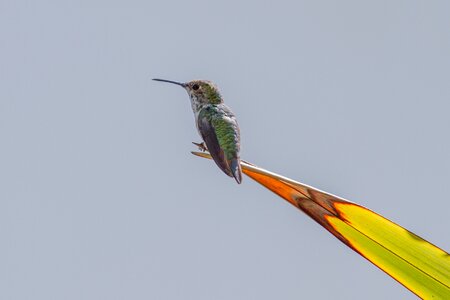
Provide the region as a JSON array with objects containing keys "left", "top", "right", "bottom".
[{"left": 0, "top": 0, "right": 450, "bottom": 300}]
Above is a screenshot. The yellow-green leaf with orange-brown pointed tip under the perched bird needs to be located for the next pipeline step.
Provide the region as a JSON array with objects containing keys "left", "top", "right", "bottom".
[{"left": 192, "top": 152, "right": 450, "bottom": 299}]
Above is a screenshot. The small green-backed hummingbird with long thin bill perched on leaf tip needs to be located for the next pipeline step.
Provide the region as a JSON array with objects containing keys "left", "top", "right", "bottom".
[{"left": 153, "top": 78, "right": 242, "bottom": 183}]
